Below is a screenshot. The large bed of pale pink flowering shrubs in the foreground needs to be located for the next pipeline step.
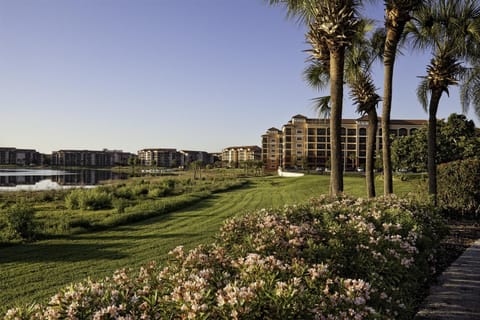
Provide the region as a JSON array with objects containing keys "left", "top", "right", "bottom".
[{"left": 5, "top": 198, "right": 443, "bottom": 319}]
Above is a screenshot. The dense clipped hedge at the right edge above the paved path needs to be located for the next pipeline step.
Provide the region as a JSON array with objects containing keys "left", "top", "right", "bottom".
[{"left": 437, "top": 159, "right": 480, "bottom": 218}]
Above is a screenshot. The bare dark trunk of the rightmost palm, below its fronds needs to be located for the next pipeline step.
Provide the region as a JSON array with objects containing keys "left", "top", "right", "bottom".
[{"left": 427, "top": 90, "right": 442, "bottom": 206}]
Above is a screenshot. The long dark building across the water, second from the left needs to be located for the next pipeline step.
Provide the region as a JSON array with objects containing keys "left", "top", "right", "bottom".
[{"left": 51, "top": 149, "right": 135, "bottom": 167}]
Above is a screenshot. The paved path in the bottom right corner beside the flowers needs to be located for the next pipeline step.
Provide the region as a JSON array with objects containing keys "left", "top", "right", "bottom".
[{"left": 415, "top": 239, "right": 480, "bottom": 320}]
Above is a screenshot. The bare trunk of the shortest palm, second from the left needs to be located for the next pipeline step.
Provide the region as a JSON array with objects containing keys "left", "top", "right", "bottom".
[{"left": 365, "top": 108, "right": 378, "bottom": 198}]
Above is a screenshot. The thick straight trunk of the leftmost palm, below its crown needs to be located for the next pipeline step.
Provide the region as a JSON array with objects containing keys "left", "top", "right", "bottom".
[{"left": 330, "top": 47, "right": 345, "bottom": 196}]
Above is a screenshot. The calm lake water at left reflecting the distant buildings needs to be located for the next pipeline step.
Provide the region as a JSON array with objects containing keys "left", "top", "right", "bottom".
[{"left": 0, "top": 169, "right": 128, "bottom": 192}]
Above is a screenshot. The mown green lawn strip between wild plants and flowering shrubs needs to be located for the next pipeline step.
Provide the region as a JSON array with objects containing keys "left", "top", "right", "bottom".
[{"left": 0, "top": 176, "right": 420, "bottom": 310}]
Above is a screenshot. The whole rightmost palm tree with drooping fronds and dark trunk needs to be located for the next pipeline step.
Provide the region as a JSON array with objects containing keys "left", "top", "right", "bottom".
[{"left": 407, "top": 0, "right": 480, "bottom": 204}]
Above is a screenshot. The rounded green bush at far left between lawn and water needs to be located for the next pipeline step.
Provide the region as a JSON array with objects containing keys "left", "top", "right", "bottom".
[{"left": 1, "top": 203, "right": 36, "bottom": 240}]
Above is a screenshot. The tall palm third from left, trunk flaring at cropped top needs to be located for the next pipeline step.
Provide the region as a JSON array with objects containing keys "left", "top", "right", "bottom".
[{"left": 382, "top": 0, "right": 424, "bottom": 195}]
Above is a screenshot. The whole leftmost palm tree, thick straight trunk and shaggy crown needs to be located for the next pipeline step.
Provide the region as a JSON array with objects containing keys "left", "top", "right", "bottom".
[{"left": 268, "top": 0, "right": 361, "bottom": 195}]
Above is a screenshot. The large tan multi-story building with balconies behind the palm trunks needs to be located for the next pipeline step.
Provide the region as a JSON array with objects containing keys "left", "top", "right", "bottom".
[{"left": 262, "top": 115, "right": 427, "bottom": 170}]
